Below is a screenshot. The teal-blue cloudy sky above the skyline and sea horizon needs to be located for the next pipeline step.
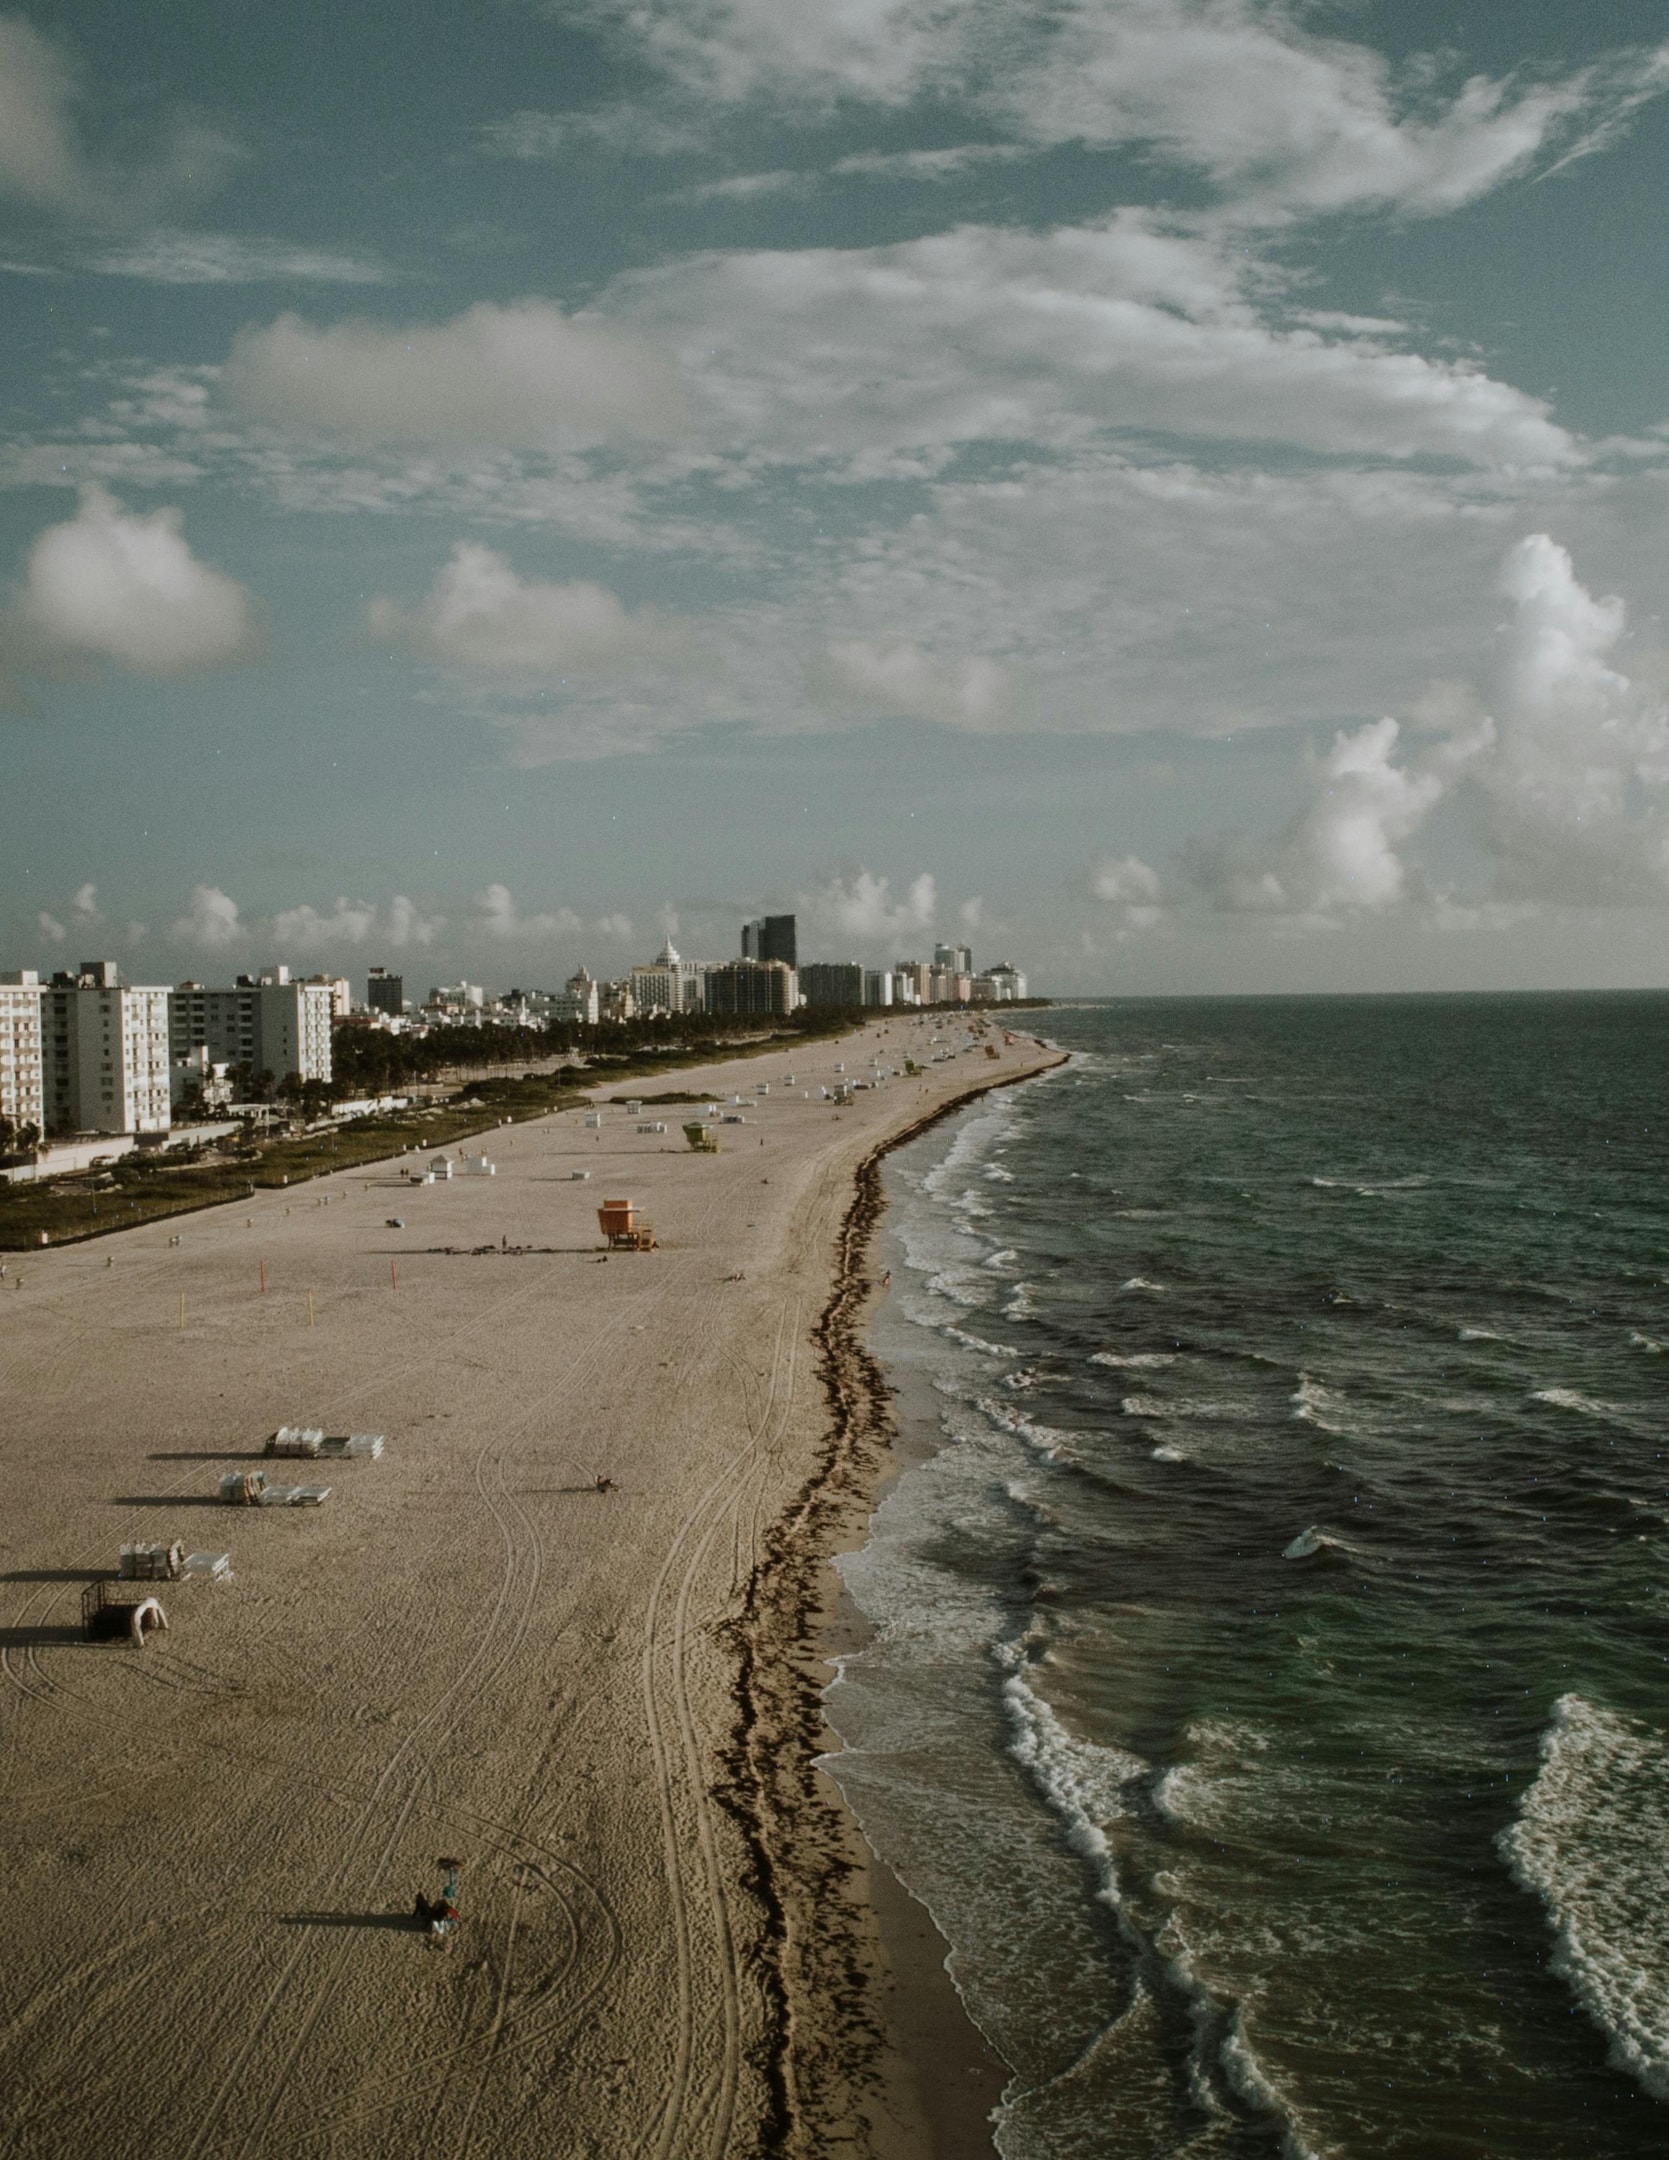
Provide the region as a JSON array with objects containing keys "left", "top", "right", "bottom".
[{"left": 0, "top": 0, "right": 1669, "bottom": 996}]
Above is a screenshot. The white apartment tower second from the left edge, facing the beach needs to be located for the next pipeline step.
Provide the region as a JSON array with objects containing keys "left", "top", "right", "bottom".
[{"left": 41, "top": 959, "right": 168, "bottom": 1132}]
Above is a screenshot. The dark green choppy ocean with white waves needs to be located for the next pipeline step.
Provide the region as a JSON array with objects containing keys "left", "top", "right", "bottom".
[{"left": 827, "top": 994, "right": 1669, "bottom": 2160}]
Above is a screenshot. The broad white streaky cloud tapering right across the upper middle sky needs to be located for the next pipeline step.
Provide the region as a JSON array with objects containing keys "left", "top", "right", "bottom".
[{"left": 605, "top": 210, "right": 1578, "bottom": 467}]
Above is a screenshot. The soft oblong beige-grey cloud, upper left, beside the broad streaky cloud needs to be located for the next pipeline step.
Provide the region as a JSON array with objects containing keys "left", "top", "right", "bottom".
[{"left": 225, "top": 300, "right": 684, "bottom": 447}]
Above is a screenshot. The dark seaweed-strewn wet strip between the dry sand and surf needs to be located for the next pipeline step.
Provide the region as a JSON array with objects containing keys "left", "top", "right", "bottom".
[{"left": 723, "top": 1043, "right": 1069, "bottom": 2160}]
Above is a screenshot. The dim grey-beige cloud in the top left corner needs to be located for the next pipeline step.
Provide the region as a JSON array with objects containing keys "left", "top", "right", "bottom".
[{"left": 0, "top": 15, "right": 235, "bottom": 225}]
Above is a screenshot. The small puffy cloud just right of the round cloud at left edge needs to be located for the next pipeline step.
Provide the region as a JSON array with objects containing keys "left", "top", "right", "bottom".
[{"left": 365, "top": 540, "right": 695, "bottom": 676}]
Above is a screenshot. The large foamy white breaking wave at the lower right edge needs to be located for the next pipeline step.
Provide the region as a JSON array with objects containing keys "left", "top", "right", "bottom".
[{"left": 1498, "top": 1696, "right": 1669, "bottom": 2100}]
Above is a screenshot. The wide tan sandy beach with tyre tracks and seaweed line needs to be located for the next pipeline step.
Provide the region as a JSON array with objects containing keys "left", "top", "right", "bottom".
[{"left": 0, "top": 1020, "right": 1054, "bottom": 2160}]
